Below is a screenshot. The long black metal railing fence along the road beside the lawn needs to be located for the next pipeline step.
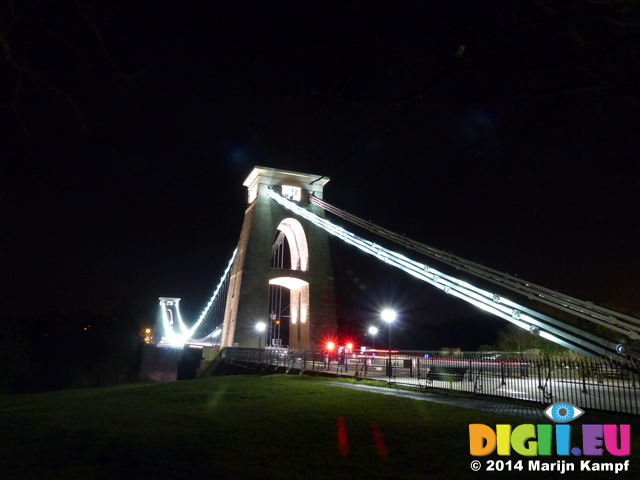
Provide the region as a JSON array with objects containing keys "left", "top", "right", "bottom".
[{"left": 223, "top": 348, "right": 640, "bottom": 415}]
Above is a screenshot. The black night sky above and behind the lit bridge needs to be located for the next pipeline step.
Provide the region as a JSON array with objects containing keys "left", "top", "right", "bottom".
[{"left": 0, "top": 0, "right": 640, "bottom": 349}]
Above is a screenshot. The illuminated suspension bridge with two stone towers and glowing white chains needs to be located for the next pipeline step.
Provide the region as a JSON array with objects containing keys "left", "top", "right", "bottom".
[{"left": 148, "top": 167, "right": 640, "bottom": 413}]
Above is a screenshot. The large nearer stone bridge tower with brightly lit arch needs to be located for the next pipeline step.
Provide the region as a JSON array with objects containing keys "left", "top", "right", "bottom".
[{"left": 221, "top": 167, "right": 337, "bottom": 350}]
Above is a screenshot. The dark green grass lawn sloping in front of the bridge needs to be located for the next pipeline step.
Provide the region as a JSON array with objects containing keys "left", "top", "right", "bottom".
[{"left": 0, "top": 375, "right": 640, "bottom": 480}]
